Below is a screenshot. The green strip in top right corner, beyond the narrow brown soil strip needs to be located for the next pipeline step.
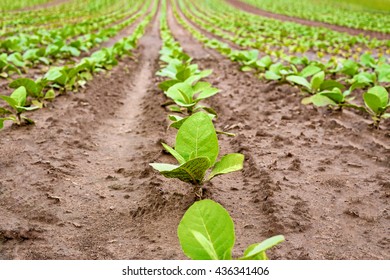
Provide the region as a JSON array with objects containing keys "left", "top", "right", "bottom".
[{"left": 243, "top": 0, "right": 390, "bottom": 33}]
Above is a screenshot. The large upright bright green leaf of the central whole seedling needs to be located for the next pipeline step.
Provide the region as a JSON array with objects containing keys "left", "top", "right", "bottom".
[{"left": 175, "top": 112, "right": 219, "bottom": 166}]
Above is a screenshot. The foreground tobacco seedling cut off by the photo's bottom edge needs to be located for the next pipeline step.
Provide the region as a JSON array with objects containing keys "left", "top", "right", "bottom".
[{"left": 177, "top": 199, "right": 285, "bottom": 260}]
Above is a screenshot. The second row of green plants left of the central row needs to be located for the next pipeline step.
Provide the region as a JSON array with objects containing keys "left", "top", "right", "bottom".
[{"left": 0, "top": 0, "right": 150, "bottom": 78}]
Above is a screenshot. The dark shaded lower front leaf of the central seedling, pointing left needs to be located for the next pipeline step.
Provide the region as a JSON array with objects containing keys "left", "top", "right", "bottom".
[{"left": 150, "top": 157, "right": 210, "bottom": 184}]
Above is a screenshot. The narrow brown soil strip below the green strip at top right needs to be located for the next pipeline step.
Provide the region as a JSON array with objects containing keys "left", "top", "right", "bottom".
[{"left": 225, "top": 0, "right": 390, "bottom": 40}]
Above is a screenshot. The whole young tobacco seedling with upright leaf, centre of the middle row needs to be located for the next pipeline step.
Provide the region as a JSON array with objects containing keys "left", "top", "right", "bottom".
[{"left": 150, "top": 112, "right": 244, "bottom": 192}]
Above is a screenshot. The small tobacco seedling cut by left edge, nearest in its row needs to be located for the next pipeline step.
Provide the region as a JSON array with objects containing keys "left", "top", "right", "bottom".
[{"left": 0, "top": 86, "right": 39, "bottom": 129}]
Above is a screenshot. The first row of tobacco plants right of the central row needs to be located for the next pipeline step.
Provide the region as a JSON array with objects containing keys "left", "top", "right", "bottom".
[{"left": 173, "top": 1, "right": 390, "bottom": 127}]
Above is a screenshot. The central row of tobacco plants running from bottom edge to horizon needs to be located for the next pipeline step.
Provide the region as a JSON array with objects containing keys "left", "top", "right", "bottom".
[{"left": 150, "top": 0, "right": 284, "bottom": 260}]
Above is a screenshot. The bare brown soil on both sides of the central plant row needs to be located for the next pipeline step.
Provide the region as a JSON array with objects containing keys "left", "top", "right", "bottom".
[{"left": 0, "top": 0, "right": 390, "bottom": 259}]
